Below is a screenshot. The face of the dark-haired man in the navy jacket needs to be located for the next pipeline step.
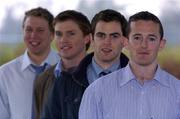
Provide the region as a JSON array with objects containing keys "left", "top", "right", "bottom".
[{"left": 92, "top": 21, "right": 125, "bottom": 63}]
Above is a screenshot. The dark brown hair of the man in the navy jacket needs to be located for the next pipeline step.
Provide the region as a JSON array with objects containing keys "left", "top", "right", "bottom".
[{"left": 91, "top": 9, "right": 127, "bottom": 36}]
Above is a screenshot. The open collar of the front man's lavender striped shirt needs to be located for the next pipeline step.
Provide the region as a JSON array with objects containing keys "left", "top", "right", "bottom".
[{"left": 120, "top": 64, "right": 169, "bottom": 87}]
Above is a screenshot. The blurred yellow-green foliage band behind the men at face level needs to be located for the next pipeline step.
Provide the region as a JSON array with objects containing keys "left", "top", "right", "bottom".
[{"left": 0, "top": 42, "right": 180, "bottom": 79}]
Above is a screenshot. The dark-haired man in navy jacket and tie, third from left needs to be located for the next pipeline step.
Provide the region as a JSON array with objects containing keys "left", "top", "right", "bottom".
[{"left": 41, "top": 9, "right": 128, "bottom": 119}]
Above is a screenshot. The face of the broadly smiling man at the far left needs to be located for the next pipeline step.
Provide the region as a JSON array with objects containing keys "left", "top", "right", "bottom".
[{"left": 23, "top": 16, "right": 53, "bottom": 55}]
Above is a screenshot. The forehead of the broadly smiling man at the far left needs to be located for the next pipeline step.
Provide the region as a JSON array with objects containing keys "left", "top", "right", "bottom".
[{"left": 24, "top": 16, "right": 48, "bottom": 27}]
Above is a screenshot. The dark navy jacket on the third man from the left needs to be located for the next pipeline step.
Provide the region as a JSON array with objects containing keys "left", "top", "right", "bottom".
[{"left": 41, "top": 53, "right": 129, "bottom": 119}]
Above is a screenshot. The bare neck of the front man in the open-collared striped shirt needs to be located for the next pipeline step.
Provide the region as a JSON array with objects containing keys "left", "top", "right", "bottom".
[{"left": 129, "top": 60, "right": 157, "bottom": 83}]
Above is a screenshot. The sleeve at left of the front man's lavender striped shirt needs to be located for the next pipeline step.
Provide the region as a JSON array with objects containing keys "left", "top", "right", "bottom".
[{"left": 79, "top": 85, "right": 103, "bottom": 119}]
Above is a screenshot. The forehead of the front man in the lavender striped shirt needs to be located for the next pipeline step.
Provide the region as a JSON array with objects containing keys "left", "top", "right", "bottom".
[{"left": 130, "top": 20, "right": 160, "bottom": 35}]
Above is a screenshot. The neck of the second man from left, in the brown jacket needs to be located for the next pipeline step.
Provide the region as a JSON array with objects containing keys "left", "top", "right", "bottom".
[{"left": 61, "top": 53, "right": 86, "bottom": 71}]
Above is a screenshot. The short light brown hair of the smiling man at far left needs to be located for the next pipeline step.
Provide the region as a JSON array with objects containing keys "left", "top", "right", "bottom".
[{"left": 23, "top": 7, "right": 54, "bottom": 32}]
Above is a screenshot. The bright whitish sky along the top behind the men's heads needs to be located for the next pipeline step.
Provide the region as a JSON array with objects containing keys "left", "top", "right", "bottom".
[{"left": 0, "top": 0, "right": 180, "bottom": 44}]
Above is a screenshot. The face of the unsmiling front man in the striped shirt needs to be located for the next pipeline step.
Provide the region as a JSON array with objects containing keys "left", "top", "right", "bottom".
[{"left": 127, "top": 20, "right": 165, "bottom": 66}]
